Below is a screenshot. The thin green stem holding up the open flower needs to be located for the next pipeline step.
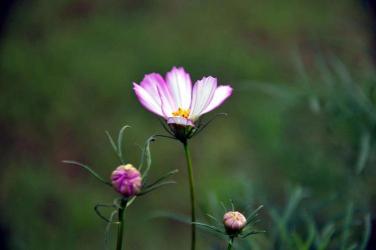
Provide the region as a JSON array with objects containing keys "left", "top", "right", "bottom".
[{"left": 183, "top": 142, "right": 196, "bottom": 250}]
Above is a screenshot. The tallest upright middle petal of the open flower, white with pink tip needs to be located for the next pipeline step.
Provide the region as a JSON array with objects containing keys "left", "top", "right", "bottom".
[{"left": 166, "top": 67, "right": 192, "bottom": 109}]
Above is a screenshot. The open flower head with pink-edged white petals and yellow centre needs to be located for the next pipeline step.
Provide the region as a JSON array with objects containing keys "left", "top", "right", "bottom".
[{"left": 133, "top": 67, "right": 232, "bottom": 127}]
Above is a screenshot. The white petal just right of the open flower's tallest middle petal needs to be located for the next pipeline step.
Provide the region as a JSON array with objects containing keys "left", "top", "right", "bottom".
[{"left": 189, "top": 76, "right": 217, "bottom": 120}]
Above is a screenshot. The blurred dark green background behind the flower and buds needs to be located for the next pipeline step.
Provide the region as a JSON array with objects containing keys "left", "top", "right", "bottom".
[{"left": 0, "top": 0, "right": 376, "bottom": 250}]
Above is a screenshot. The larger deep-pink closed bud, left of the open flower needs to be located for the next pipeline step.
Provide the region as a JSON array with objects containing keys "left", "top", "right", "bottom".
[{"left": 111, "top": 164, "right": 142, "bottom": 197}]
